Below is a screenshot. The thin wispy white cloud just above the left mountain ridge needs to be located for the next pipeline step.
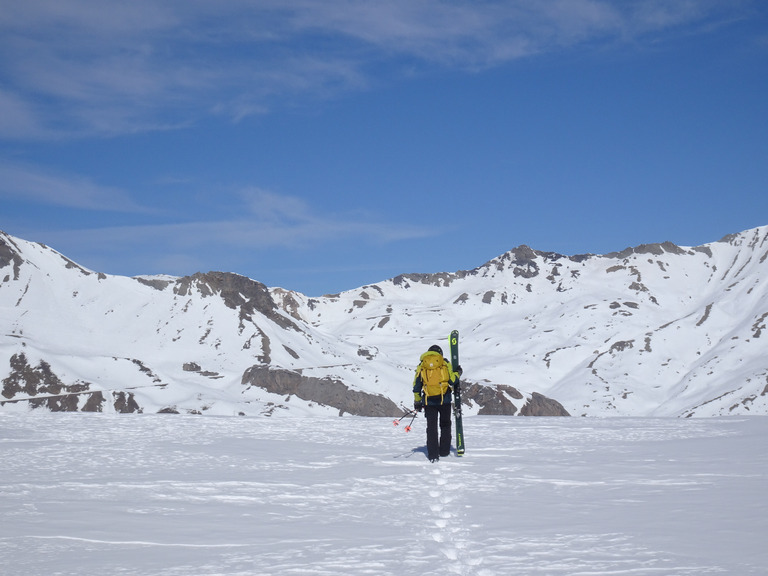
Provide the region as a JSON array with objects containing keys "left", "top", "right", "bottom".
[{"left": 29, "top": 188, "right": 442, "bottom": 274}]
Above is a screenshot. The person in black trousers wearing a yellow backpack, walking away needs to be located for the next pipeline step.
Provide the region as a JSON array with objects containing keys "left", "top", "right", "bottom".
[{"left": 413, "top": 344, "right": 462, "bottom": 462}]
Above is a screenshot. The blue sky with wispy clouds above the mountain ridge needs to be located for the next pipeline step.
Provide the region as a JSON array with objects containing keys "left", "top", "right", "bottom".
[{"left": 0, "top": 0, "right": 768, "bottom": 296}]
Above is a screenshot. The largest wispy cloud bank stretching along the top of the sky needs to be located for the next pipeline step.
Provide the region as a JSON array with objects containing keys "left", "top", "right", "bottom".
[{"left": 0, "top": 0, "right": 753, "bottom": 138}]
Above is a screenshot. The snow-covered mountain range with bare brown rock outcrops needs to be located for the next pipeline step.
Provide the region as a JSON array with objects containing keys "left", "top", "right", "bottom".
[{"left": 0, "top": 226, "right": 768, "bottom": 416}]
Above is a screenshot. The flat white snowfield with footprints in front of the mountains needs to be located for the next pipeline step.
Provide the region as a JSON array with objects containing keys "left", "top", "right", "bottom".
[{"left": 0, "top": 411, "right": 768, "bottom": 576}]
